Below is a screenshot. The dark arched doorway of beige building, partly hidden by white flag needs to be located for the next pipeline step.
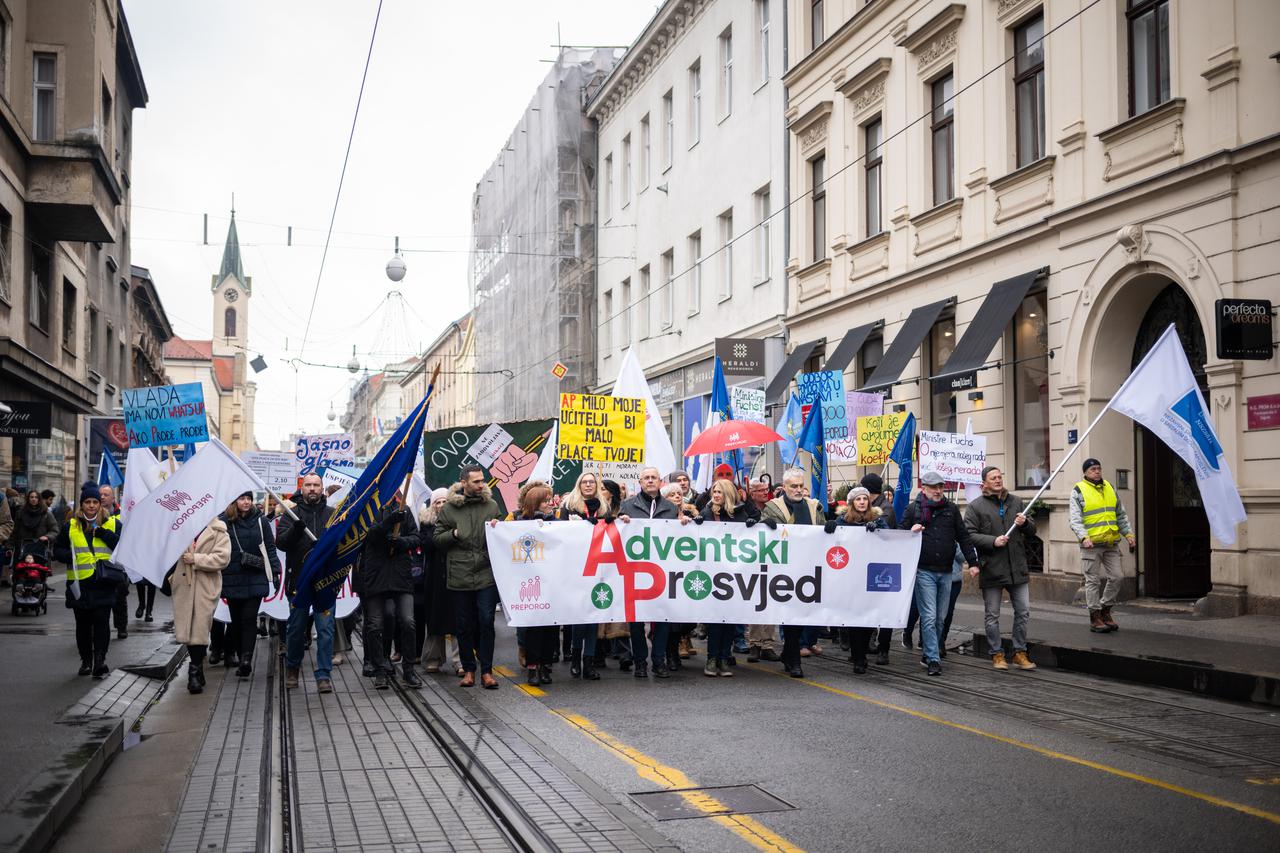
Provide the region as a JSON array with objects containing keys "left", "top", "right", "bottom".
[{"left": 1133, "top": 283, "right": 1212, "bottom": 598}]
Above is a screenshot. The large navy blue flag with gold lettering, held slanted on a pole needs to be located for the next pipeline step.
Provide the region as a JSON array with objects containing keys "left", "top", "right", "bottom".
[{"left": 293, "top": 377, "right": 434, "bottom": 612}]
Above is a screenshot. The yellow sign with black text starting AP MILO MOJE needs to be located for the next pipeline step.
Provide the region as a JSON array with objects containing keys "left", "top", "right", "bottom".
[{"left": 556, "top": 393, "right": 645, "bottom": 464}]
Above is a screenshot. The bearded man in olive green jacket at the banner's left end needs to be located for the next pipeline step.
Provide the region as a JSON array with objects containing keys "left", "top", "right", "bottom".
[{"left": 431, "top": 465, "right": 502, "bottom": 690}]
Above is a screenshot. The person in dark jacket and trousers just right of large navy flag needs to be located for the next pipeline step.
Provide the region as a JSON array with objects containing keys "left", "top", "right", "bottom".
[{"left": 360, "top": 500, "right": 422, "bottom": 690}]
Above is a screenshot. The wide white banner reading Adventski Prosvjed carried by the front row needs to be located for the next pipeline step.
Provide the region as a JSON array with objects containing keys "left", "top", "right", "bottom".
[{"left": 485, "top": 520, "right": 920, "bottom": 628}]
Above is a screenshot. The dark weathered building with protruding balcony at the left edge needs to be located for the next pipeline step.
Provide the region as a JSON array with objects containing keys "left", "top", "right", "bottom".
[{"left": 0, "top": 0, "right": 147, "bottom": 500}]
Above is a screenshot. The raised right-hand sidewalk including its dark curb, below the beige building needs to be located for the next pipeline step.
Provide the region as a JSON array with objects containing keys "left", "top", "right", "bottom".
[{"left": 955, "top": 596, "right": 1280, "bottom": 706}]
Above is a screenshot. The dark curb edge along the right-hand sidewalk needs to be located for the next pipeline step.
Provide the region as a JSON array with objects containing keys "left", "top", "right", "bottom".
[{"left": 972, "top": 631, "right": 1280, "bottom": 707}]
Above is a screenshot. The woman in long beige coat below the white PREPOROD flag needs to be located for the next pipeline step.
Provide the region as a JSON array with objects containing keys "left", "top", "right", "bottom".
[{"left": 169, "top": 517, "right": 232, "bottom": 693}]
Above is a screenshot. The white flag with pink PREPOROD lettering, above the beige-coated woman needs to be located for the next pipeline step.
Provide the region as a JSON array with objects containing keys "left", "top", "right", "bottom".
[{"left": 111, "top": 438, "right": 266, "bottom": 587}]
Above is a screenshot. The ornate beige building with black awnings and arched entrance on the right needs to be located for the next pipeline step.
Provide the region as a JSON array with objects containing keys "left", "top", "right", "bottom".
[{"left": 785, "top": 0, "right": 1280, "bottom": 613}]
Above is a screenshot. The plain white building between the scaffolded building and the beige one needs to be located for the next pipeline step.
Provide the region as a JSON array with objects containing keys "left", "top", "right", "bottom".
[{"left": 588, "top": 0, "right": 787, "bottom": 459}]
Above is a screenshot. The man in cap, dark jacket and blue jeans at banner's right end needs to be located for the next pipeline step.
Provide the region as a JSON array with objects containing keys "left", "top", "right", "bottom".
[{"left": 899, "top": 471, "right": 978, "bottom": 675}]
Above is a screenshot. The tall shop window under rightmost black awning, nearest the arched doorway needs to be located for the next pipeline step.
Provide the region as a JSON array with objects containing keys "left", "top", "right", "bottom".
[{"left": 1014, "top": 291, "right": 1050, "bottom": 488}]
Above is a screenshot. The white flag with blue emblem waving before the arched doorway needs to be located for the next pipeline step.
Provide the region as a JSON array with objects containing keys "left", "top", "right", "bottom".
[{"left": 1110, "top": 324, "right": 1244, "bottom": 544}]
